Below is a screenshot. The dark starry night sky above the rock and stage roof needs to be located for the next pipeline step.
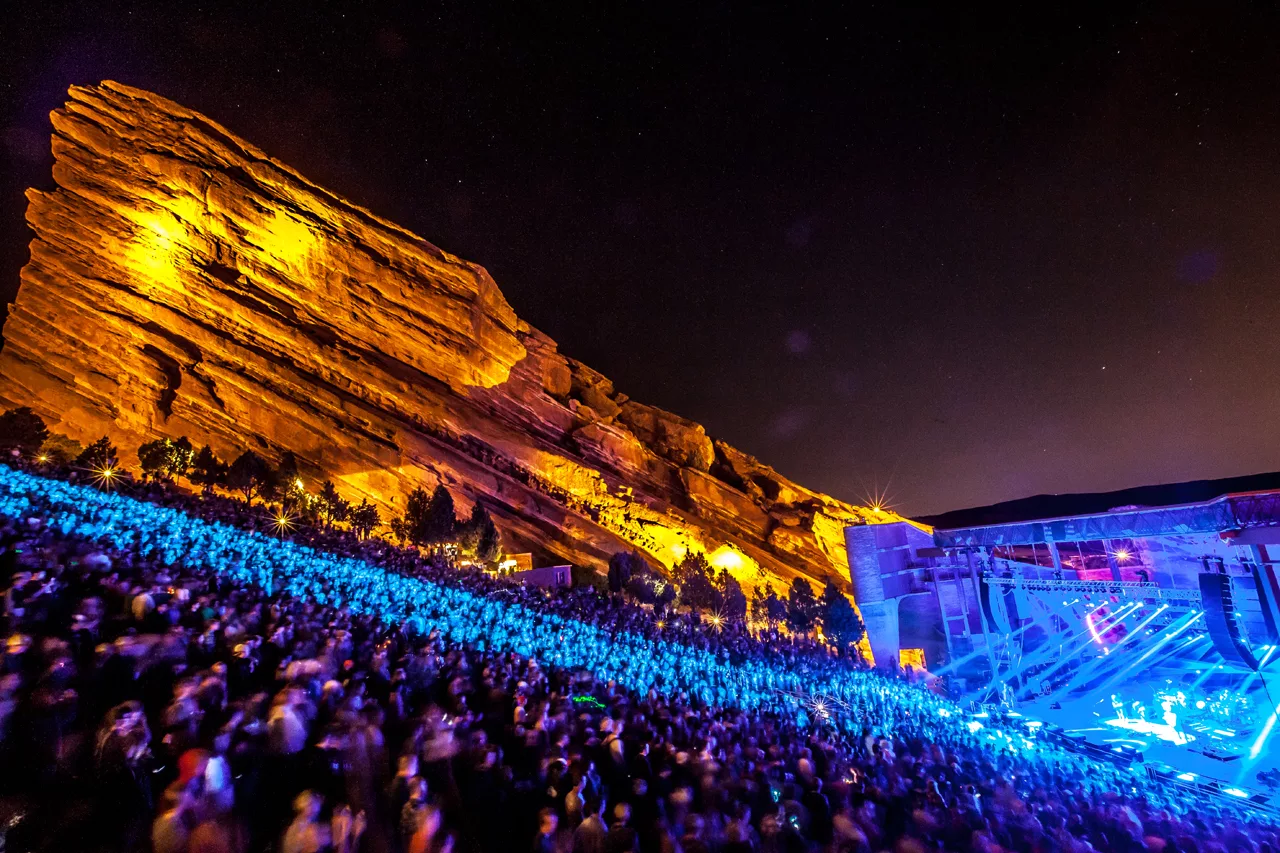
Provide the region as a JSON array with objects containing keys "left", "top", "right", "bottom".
[{"left": 0, "top": 3, "right": 1280, "bottom": 514}]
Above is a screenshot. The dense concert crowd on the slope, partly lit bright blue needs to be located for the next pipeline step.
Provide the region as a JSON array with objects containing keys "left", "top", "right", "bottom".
[{"left": 0, "top": 466, "right": 1280, "bottom": 853}]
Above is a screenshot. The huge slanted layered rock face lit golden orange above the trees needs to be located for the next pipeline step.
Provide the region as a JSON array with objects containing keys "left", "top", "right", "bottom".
[{"left": 0, "top": 82, "right": 896, "bottom": 584}]
